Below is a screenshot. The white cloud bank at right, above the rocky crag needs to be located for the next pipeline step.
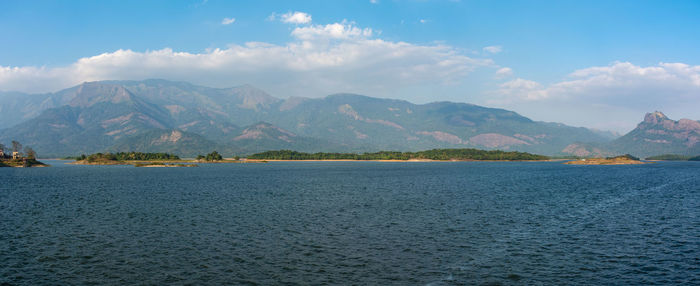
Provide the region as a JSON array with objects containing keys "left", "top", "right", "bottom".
[{"left": 489, "top": 62, "right": 700, "bottom": 132}]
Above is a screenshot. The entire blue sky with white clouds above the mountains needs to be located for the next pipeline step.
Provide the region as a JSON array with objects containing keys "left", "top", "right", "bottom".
[{"left": 0, "top": 0, "right": 700, "bottom": 133}]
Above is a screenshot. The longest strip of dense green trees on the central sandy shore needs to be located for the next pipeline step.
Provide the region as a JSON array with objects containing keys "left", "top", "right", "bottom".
[{"left": 248, "top": 148, "right": 549, "bottom": 161}]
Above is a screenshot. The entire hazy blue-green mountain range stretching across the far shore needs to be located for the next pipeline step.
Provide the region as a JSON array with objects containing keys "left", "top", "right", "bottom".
[{"left": 0, "top": 80, "right": 700, "bottom": 156}]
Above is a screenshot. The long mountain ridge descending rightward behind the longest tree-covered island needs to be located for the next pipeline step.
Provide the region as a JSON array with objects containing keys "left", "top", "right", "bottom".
[{"left": 266, "top": 94, "right": 607, "bottom": 154}]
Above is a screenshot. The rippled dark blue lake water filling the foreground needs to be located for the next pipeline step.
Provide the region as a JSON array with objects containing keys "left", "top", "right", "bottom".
[{"left": 0, "top": 161, "right": 700, "bottom": 285}]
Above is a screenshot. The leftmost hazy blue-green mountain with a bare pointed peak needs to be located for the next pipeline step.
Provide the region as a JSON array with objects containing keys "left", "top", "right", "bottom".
[{"left": 0, "top": 84, "right": 170, "bottom": 156}]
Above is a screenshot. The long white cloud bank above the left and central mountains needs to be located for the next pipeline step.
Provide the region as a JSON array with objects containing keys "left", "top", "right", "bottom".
[{"left": 0, "top": 22, "right": 495, "bottom": 98}]
